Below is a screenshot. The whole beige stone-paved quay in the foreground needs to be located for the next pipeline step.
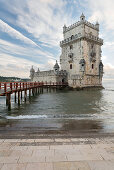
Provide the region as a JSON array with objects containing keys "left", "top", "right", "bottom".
[{"left": 0, "top": 137, "right": 114, "bottom": 170}]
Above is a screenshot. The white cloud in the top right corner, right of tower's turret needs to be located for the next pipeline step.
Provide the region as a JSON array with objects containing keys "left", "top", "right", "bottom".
[{"left": 86, "top": 0, "right": 114, "bottom": 30}]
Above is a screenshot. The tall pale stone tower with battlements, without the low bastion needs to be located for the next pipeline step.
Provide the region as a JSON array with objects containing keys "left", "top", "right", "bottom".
[{"left": 60, "top": 14, "right": 103, "bottom": 88}]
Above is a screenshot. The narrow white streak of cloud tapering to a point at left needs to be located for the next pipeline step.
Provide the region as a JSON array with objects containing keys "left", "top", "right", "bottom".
[{"left": 0, "top": 19, "right": 38, "bottom": 46}]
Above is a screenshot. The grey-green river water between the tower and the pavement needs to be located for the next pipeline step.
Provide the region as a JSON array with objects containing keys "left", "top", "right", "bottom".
[{"left": 0, "top": 80, "right": 114, "bottom": 135}]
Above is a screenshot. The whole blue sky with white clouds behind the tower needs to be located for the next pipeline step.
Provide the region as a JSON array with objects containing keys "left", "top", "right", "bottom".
[{"left": 0, "top": 0, "right": 114, "bottom": 77}]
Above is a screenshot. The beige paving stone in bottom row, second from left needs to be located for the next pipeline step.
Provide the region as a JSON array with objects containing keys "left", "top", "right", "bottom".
[{"left": 26, "top": 163, "right": 53, "bottom": 170}]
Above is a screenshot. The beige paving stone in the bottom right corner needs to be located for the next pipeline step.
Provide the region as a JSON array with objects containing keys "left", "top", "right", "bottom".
[{"left": 88, "top": 161, "right": 114, "bottom": 170}]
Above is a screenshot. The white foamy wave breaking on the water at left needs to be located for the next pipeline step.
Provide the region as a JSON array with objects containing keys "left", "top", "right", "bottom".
[{"left": 5, "top": 115, "right": 47, "bottom": 120}]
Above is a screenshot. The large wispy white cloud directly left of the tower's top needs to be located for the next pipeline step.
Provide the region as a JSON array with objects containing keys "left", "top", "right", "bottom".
[{"left": 0, "top": 0, "right": 72, "bottom": 46}]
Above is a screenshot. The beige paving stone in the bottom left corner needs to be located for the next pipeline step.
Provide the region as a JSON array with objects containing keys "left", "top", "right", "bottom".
[{"left": 1, "top": 164, "right": 27, "bottom": 170}]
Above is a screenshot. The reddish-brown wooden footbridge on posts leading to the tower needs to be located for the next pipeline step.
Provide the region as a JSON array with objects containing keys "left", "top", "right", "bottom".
[{"left": 0, "top": 82, "right": 68, "bottom": 110}]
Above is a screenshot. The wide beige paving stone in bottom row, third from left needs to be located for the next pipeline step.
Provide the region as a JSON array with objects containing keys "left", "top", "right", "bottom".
[{"left": 53, "top": 162, "right": 91, "bottom": 170}]
